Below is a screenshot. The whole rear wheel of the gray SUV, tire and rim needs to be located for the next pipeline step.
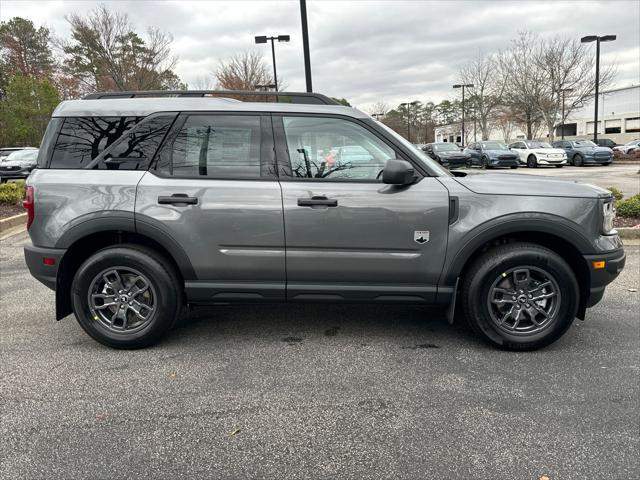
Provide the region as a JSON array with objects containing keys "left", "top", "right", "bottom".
[{"left": 71, "top": 245, "right": 182, "bottom": 349}]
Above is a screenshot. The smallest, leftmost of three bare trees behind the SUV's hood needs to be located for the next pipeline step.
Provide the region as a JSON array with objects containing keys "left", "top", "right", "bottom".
[{"left": 460, "top": 52, "right": 506, "bottom": 140}]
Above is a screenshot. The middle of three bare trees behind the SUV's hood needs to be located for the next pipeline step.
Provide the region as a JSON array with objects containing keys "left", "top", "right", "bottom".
[{"left": 497, "top": 32, "right": 545, "bottom": 139}]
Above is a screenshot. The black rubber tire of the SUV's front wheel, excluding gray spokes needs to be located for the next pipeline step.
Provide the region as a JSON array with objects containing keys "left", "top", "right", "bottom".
[{"left": 462, "top": 243, "right": 579, "bottom": 350}]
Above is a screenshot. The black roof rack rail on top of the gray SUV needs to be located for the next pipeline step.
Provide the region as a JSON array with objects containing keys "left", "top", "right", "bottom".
[{"left": 83, "top": 90, "right": 340, "bottom": 105}]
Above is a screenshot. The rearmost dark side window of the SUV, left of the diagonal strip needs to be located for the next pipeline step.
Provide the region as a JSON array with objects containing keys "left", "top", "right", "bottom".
[{"left": 51, "top": 117, "right": 142, "bottom": 168}]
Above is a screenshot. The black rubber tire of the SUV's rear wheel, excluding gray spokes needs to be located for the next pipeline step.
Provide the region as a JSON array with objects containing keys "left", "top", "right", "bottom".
[{"left": 71, "top": 244, "right": 183, "bottom": 349}]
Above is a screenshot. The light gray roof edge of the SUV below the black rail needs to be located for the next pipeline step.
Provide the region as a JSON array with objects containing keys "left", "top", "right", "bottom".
[{"left": 52, "top": 97, "right": 369, "bottom": 118}]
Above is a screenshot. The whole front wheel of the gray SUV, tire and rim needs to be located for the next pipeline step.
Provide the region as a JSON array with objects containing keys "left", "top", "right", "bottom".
[{"left": 462, "top": 243, "right": 579, "bottom": 350}]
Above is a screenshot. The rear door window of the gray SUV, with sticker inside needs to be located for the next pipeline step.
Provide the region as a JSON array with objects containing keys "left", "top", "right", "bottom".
[{"left": 158, "top": 115, "right": 261, "bottom": 178}]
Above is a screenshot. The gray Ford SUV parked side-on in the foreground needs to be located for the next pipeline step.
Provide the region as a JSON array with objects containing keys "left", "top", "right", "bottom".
[{"left": 24, "top": 92, "right": 625, "bottom": 350}]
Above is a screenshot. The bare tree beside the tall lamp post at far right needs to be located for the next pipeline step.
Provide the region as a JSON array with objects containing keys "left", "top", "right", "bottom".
[{"left": 535, "top": 37, "right": 615, "bottom": 140}]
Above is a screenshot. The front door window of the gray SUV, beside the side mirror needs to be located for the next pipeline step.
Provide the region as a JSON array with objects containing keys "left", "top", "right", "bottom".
[{"left": 282, "top": 117, "right": 396, "bottom": 180}]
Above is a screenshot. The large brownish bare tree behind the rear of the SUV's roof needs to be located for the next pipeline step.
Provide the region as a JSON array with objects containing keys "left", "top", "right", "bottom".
[{"left": 62, "top": 5, "right": 184, "bottom": 90}]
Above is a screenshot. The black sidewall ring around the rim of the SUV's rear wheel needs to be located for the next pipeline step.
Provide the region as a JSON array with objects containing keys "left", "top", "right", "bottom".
[{"left": 71, "top": 248, "right": 179, "bottom": 348}]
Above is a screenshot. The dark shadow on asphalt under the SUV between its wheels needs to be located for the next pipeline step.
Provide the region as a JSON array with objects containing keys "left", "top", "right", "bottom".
[{"left": 168, "top": 304, "right": 482, "bottom": 349}]
